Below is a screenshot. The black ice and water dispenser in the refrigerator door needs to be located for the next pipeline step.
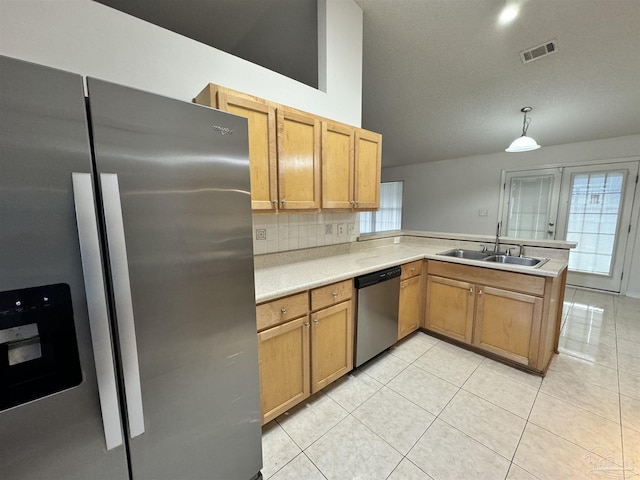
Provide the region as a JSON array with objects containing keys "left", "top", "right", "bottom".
[{"left": 0, "top": 283, "right": 82, "bottom": 411}]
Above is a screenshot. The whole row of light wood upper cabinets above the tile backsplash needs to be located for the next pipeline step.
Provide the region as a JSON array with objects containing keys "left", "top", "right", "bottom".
[{"left": 194, "top": 83, "right": 382, "bottom": 212}]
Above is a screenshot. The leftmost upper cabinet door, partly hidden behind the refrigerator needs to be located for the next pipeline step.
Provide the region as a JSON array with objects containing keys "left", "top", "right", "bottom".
[{"left": 218, "top": 89, "right": 278, "bottom": 210}]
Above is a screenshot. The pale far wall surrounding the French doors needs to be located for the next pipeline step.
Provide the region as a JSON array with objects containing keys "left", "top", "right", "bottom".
[{"left": 382, "top": 135, "right": 640, "bottom": 297}]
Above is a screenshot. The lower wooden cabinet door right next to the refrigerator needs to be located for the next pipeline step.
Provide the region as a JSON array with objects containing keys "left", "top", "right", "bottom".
[{"left": 258, "top": 315, "right": 311, "bottom": 425}]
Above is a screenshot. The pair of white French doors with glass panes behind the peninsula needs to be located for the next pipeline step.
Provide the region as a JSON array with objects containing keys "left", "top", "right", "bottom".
[{"left": 502, "top": 162, "right": 638, "bottom": 292}]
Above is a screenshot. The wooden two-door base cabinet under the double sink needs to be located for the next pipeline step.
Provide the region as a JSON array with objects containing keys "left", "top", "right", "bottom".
[{"left": 425, "top": 261, "right": 566, "bottom": 373}]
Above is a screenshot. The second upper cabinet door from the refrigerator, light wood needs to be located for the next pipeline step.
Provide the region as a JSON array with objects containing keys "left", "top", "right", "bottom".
[{"left": 277, "top": 108, "right": 320, "bottom": 210}]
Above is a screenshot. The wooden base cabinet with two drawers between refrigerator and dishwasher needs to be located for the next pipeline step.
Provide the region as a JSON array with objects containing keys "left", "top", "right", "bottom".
[{"left": 257, "top": 280, "right": 353, "bottom": 425}]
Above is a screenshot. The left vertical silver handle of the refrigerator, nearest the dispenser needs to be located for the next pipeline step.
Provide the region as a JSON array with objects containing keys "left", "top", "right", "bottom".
[{"left": 72, "top": 172, "right": 122, "bottom": 450}]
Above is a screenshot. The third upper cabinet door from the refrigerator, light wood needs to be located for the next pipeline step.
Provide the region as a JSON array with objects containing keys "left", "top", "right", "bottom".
[{"left": 322, "top": 122, "right": 355, "bottom": 209}]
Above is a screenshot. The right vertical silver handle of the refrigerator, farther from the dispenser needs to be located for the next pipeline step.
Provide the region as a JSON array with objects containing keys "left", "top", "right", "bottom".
[{"left": 100, "top": 173, "right": 144, "bottom": 438}]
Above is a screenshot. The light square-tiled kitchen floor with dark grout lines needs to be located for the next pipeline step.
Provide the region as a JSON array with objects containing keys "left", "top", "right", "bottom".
[{"left": 262, "top": 288, "right": 640, "bottom": 480}]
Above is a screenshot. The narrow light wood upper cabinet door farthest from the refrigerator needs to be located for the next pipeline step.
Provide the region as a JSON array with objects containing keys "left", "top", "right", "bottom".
[{"left": 354, "top": 129, "right": 382, "bottom": 210}]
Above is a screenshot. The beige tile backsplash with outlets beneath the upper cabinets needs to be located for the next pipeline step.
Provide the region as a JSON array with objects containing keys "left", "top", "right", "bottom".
[{"left": 253, "top": 213, "right": 360, "bottom": 255}]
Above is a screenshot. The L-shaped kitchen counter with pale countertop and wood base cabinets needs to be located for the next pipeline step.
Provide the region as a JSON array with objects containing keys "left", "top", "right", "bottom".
[{"left": 255, "top": 231, "right": 575, "bottom": 423}]
